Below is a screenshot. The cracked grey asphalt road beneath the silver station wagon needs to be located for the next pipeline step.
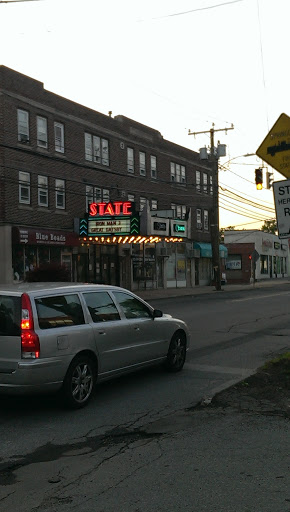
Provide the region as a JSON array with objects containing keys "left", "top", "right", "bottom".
[{"left": 0, "top": 286, "right": 290, "bottom": 512}]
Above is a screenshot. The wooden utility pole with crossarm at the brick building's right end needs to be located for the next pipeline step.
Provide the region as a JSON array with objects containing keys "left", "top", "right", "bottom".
[{"left": 188, "top": 123, "right": 234, "bottom": 291}]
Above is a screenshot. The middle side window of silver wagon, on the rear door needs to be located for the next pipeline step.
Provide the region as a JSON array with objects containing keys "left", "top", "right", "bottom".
[{"left": 83, "top": 292, "right": 120, "bottom": 323}]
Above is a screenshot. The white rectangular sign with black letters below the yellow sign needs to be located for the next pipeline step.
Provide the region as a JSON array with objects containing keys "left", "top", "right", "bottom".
[{"left": 273, "top": 180, "right": 290, "bottom": 238}]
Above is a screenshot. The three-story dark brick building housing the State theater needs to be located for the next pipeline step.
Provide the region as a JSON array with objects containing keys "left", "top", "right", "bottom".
[{"left": 0, "top": 66, "right": 222, "bottom": 289}]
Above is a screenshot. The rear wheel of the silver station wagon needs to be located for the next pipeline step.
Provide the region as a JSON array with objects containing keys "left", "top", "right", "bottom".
[{"left": 62, "top": 355, "right": 97, "bottom": 409}]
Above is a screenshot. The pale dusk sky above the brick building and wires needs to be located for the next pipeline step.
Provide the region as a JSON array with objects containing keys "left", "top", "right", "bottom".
[{"left": 0, "top": 0, "right": 290, "bottom": 229}]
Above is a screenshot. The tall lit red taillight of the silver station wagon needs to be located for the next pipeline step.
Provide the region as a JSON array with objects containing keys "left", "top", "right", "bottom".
[{"left": 21, "top": 293, "right": 40, "bottom": 359}]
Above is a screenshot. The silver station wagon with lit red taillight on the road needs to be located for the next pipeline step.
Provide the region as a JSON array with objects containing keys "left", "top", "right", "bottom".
[{"left": 0, "top": 283, "right": 190, "bottom": 408}]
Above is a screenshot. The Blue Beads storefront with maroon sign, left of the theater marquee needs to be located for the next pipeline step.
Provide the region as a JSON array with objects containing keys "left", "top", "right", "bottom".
[{"left": 12, "top": 227, "right": 80, "bottom": 281}]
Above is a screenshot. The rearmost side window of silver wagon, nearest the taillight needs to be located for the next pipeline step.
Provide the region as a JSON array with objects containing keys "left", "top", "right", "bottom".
[{"left": 35, "top": 294, "right": 85, "bottom": 329}]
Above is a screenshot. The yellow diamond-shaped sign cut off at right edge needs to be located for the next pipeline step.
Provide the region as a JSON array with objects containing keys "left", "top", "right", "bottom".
[{"left": 256, "top": 114, "right": 290, "bottom": 178}]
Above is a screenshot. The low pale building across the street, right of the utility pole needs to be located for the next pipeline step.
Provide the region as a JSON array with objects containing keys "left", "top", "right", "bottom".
[{"left": 224, "top": 230, "right": 289, "bottom": 283}]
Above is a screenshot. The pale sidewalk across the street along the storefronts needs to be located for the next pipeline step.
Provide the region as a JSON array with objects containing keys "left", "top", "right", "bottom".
[{"left": 134, "top": 277, "right": 290, "bottom": 301}]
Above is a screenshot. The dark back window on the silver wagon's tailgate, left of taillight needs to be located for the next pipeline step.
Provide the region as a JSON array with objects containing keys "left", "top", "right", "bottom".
[{"left": 0, "top": 295, "right": 21, "bottom": 336}]
